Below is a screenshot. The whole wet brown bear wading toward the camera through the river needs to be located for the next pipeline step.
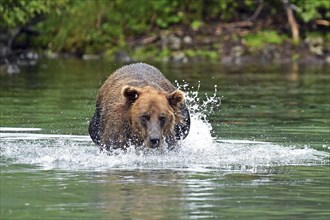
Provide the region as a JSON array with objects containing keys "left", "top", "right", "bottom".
[{"left": 89, "top": 63, "right": 190, "bottom": 150}]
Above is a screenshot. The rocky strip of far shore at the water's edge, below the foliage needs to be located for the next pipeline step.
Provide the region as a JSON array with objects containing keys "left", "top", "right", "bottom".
[{"left": 0, "top": 22, "right": 330, "bottom": 74}]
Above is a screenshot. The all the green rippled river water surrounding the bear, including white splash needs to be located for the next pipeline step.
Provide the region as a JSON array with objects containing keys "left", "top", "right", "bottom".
[{"left": 0, "top": 59, "right": 330, "bottom": 220}]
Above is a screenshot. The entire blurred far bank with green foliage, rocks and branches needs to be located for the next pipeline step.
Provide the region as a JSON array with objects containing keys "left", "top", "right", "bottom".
[{"left": 0, "top": 0, "right": 330, "bottom": 74}]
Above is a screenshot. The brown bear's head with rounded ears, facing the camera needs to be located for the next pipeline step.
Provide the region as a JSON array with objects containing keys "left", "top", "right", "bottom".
[{"left": 122, "top": 86, "right": 185, "bottom": 148}]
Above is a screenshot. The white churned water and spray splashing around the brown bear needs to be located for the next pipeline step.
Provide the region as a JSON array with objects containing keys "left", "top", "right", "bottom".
[{"left": 0, "top": 84, "right": 330, "bottom": 173}]
